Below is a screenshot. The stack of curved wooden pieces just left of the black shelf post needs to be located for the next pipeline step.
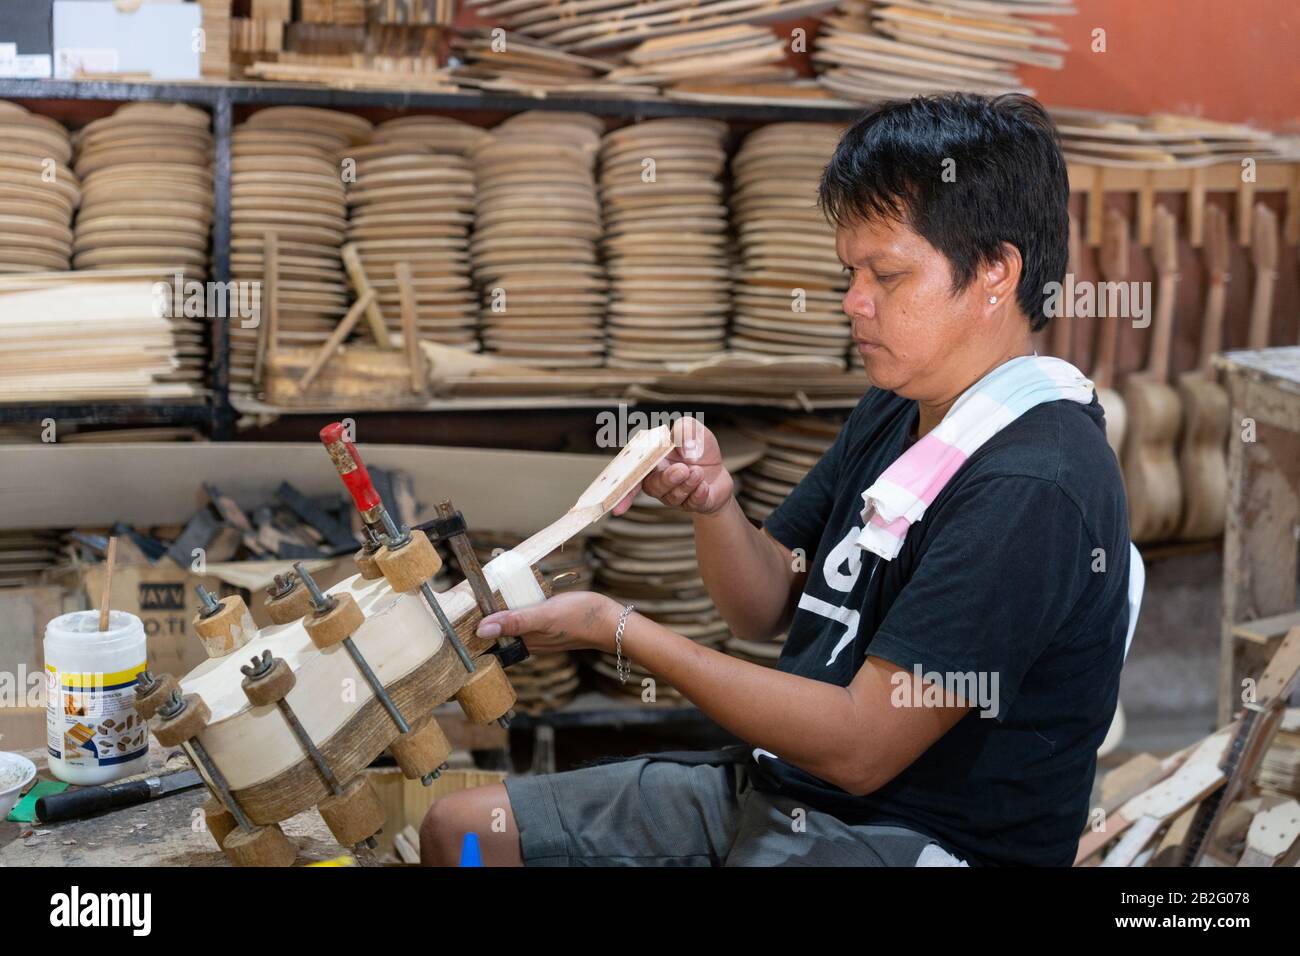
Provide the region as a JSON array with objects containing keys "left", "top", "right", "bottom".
[{"left": 73, "top": 103, "right": 212, "bottom": 280}]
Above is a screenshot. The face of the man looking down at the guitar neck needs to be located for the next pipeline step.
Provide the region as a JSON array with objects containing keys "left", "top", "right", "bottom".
[{"left": 835, "top": 214, "right": 987, "bottom": 402}]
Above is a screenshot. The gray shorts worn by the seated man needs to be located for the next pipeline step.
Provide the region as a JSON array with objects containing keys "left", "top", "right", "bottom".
[{"left": 506, "top": 754, "right": 966, "bottom": 866}]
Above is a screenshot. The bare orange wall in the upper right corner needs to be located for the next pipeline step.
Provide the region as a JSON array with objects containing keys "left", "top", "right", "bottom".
[{"left": 1021, "top": 0, "right": 1300, "bottom": 133}]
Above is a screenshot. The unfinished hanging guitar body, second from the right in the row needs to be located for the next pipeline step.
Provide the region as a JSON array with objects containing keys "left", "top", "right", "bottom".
[{"left": 1123, "top": 380, "right": 1183, "bottom": 544}]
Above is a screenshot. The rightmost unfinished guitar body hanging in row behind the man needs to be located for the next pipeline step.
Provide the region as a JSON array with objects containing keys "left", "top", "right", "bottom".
[{"left": 1178, "top": 372, "right": 1229, "bottom": 541}]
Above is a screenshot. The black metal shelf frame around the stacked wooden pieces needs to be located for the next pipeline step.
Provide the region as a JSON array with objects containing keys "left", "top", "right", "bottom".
[{"left": 0, "top": 78, "right": 862, "bottom": 441}]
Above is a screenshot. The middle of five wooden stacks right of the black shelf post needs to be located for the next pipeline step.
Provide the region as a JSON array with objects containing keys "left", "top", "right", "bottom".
[{"left": 471, "top": 113, "right": 607, "bottom": 368}]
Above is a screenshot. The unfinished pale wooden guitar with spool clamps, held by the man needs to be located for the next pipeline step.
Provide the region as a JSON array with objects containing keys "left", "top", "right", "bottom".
[{"left": 153, "top": 427, "right": 672, "bottom": 837}]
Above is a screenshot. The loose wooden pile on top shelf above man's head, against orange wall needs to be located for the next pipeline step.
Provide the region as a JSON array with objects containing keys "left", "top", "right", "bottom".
[{"left": 813, "top": 0, "right": 1075, "bottom": 103}]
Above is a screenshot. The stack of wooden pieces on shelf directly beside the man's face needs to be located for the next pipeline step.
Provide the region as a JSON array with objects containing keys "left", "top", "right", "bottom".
[{"left": 728, "top": 122, "right": 852, "bottom": 363}]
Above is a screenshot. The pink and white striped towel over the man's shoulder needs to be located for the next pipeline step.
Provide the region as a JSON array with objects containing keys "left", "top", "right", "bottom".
[{"left": 858, "top": 355, "right": 1093, "bottom": 561}]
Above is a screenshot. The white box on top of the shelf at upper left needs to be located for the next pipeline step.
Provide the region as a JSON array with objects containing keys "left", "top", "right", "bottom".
[{"left": 53, "top": 0, "right": 203, "bottom": 79}]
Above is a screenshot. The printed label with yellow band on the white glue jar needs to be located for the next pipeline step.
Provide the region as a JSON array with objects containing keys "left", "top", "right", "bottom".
[{"left": 46, "top": 661, "right": 150, "bottom": 767}]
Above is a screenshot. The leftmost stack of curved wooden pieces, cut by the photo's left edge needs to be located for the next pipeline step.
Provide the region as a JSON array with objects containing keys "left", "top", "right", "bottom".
[{"left": 0, "top": 100, "right": 81, "bottom": 273}]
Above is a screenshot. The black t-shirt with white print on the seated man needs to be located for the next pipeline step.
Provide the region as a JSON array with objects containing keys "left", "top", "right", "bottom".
[{"left": 753, "top": 389, "right": 1130, "bottom": 866}]
